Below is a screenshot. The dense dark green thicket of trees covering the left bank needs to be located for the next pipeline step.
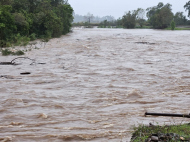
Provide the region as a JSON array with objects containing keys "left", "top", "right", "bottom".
[{"left": 0, "top": 0, "right": 73, "bottom": 47}]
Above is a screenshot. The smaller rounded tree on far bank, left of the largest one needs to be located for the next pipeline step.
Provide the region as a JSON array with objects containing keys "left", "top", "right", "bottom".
[{"left": 122, "top": 11, "right": 137, "bottom": 29}]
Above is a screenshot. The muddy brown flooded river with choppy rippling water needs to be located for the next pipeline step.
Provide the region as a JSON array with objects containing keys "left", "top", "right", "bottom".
[{"left": 0, "top": 28, "right": 190, "bottom": 142}]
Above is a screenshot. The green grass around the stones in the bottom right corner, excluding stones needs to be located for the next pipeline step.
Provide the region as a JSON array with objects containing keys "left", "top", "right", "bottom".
[{"left": 131, "top": 124, "right": 190, "bottom": 142}]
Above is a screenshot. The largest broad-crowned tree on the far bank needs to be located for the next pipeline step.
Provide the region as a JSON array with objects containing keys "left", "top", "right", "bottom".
[{"left": 147, "top": 2, "right": 173, "bottom": 29}]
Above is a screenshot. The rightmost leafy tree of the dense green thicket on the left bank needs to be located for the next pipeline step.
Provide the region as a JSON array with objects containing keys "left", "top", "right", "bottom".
[{"left": 30, "top": 1, "right": 73, "bottom": 38}]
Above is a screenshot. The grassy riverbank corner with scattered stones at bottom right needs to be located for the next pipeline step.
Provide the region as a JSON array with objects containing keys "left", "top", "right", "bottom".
[{"left": 131, "top": 124, "right": 190, "bottom": 142}]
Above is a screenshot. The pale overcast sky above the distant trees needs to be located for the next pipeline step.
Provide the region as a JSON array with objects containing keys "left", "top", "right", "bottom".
[{"left": 68, "top": 0, "right": 189, "bottom": 18}]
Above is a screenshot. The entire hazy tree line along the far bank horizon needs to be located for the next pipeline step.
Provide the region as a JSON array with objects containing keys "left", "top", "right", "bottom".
[{"left": 74, "top": 1, "right": 190, "bottom": 29}]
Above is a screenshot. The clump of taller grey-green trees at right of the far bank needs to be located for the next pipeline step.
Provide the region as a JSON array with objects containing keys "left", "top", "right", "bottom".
[{"left": 122, "top": 1, "right": 190, "bottom": 29}]
